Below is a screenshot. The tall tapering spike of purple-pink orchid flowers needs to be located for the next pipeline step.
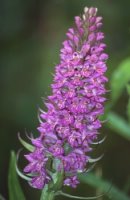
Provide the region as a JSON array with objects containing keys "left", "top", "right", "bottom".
[{"left": 24, "top": 7, "right": 108, "bottom": 189}]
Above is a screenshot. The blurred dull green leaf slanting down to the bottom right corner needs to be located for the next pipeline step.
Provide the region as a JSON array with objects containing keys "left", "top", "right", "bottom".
[{"left": 79, "top": 173, "right": 130, "bottom": 200}]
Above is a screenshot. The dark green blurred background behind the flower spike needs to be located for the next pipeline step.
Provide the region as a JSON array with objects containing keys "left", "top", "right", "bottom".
[{"left": 0, "top": 0, "right": 130, "bottom": 200}]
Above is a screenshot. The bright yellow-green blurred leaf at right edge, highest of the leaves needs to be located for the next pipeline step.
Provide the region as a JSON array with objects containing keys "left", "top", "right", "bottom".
[{"left": 111, "top": 58, "right": 130, "bottom": 103}]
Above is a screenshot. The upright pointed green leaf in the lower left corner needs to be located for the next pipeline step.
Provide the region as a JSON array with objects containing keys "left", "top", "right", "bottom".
[{"left": 8, "top": 151, "right": 25, "bottom": 200}]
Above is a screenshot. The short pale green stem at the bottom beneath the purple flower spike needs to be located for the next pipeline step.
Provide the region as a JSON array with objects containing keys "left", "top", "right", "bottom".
[{"left": 40, "top": 187, "right": 55, "bottom": 200}]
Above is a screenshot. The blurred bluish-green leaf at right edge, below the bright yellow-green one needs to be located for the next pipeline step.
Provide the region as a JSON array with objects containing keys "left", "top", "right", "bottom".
[{"left": 106, "top": 112, "right": 130, "bottom": 140}]
